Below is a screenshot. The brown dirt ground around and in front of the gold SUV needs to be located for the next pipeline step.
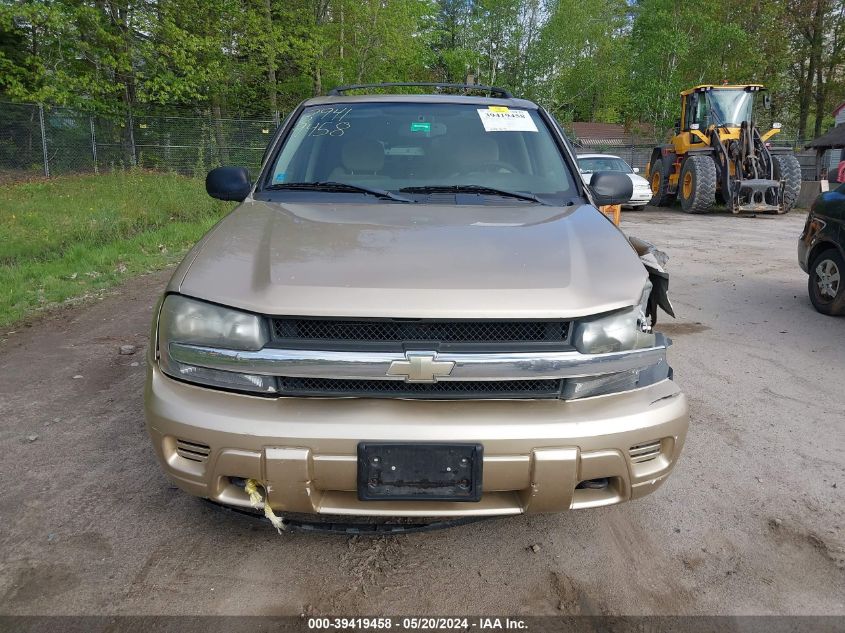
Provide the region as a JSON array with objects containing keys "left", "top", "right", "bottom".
[{"left": 0, "top": 210, "right": 845, "bottom": 615}]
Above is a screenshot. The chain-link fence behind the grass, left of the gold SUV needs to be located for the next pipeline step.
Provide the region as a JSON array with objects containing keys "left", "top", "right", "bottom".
[{"left": 0, "top": 103, "right": 276, "bottom": 180}]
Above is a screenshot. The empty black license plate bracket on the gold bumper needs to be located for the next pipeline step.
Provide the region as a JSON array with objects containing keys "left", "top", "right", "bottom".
[{"left": 358, "top": 442, "right": 484, "bottom": 501}]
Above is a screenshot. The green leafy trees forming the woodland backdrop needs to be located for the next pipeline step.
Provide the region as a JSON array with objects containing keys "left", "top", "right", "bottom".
[{"left": 0, "top": 0, "right": 845, "bottom": 139}]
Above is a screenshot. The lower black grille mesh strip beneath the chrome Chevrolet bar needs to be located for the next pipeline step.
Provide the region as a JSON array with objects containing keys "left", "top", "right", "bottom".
[{"left": 279, "top": 377, "right": 561, "bottom": 399}]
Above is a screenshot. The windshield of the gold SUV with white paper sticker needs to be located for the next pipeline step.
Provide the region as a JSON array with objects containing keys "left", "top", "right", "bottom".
[{"left": 270, "top": 103, "right": 576, "bottom": 203}]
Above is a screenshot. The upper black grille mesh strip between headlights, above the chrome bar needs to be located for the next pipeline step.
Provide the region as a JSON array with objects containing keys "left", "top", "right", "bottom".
[{"left": 273, "top": 319, "right": 568, "bottom": 343}]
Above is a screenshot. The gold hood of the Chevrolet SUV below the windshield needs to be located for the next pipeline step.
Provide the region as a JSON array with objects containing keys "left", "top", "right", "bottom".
[{"left": 169, "top": 200, "right": 647, "bottom": 318}]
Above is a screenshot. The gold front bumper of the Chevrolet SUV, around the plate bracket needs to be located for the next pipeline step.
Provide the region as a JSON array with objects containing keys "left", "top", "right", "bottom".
[{"left": 145, "top": 362, "right": 688, "bottom": 517}]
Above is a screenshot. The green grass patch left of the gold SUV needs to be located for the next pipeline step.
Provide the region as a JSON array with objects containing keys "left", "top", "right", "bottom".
[{"left": 0, "top": 171, "right": 233, "bottom": 327}]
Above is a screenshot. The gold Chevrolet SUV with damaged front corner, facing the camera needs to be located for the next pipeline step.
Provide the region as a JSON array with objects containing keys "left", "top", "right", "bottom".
[{"left": 146, "top": 84, "right": 688, "bottom": 520}]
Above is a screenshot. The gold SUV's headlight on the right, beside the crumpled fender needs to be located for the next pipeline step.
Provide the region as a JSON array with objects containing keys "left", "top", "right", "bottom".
[{"left": 572, "top": 281, "right": 654, "bottom": 354}]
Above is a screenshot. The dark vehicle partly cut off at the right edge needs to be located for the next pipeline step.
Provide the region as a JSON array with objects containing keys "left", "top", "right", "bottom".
[{"left": 798, "top": 184, "right": 845, "bottom": 316}]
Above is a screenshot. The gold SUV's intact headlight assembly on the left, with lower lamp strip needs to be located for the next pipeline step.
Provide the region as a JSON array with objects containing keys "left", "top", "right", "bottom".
[{"left": 158, "top": 295, "right": 277, "bottom": 393}]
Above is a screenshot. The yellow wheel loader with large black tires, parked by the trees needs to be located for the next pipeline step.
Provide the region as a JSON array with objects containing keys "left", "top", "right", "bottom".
[{"left": 646, "top": 84, "right": 801, "bottom": 213}]
